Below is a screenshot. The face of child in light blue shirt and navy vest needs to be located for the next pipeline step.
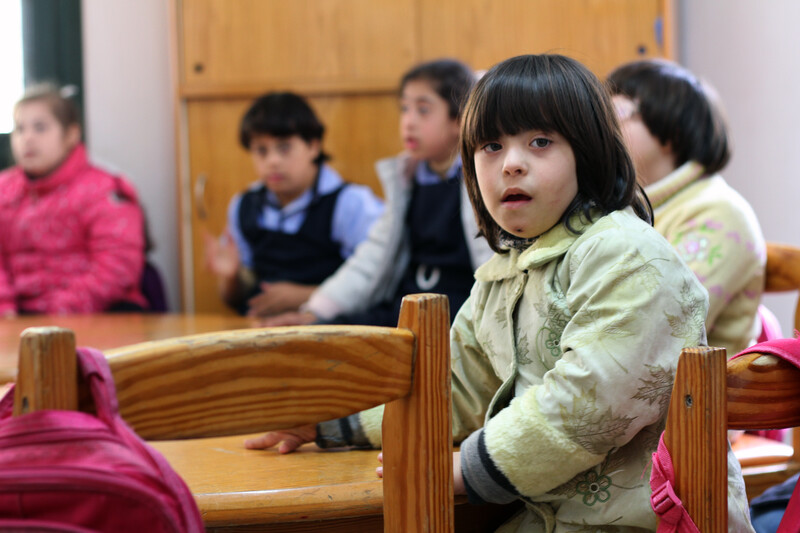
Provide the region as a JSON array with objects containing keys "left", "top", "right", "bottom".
[{"left": 250, "top": 134, "right": 320, "bottom": 206}]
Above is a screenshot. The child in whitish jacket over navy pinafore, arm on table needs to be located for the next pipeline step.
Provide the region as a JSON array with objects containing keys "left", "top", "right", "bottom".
[{"left": 264, "top": 59, "right": 491, "bottom": 326}]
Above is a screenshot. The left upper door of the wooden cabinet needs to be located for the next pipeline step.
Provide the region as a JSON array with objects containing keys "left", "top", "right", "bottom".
[{"left": 180, "top": 0, "right": 418, "bottom": 90}]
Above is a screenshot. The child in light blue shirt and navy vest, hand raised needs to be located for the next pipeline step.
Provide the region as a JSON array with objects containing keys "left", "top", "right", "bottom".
[{"left": 206, "top": 93, "right": 383, "bottom": 316}]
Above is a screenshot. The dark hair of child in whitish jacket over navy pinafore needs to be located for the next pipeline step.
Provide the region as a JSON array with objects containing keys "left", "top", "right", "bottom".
[{"left": 398, "top": 59, "right": 475, "bottom": 119}]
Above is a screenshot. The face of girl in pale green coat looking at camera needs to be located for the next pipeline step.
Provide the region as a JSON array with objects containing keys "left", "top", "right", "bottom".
[{"left": 474, "top": 130, "right": 578, "bottom": 238}]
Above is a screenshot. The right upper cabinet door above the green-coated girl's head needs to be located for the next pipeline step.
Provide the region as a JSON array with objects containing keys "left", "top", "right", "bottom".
[{"left": 420, "top": 0, "right": 664, "bottom": 78}]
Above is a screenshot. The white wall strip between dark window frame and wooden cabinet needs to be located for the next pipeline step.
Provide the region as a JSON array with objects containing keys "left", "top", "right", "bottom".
[{"left": 81, "top": 0, "right": 180, "bottom": 310}]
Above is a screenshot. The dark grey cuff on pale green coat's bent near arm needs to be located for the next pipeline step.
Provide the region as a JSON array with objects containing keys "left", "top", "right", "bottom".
[{"left": 461, "top": 429, "right": 519, "bottom": 503}]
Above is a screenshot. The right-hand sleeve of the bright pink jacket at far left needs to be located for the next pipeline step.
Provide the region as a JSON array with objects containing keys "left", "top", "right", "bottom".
[{"left": 42, "top": 179, "right": 145, "bottom": 313}]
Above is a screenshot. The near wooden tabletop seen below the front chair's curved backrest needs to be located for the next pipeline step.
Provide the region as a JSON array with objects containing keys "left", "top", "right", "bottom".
[{"left": 151, "top": 436, "right": 518, "bottom": 533}]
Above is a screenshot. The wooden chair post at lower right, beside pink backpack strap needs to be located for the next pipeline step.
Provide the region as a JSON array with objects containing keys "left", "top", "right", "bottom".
[{"left": 663, "top": 347, "right": 728, "bottom": 533}]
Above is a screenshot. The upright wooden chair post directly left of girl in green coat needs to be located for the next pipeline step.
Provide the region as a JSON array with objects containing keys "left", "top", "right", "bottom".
[{"left": 383, "top": 295, "right": 454, "bottom": 533}]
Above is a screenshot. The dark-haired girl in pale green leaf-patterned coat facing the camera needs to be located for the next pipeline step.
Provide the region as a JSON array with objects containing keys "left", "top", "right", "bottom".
[{"left": 247, "top": 55, "right": 750, "bottom": 533}]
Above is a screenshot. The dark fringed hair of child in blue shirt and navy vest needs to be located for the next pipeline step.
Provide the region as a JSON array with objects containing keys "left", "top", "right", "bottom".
[{"left": 239, "top": 92, "right": 330, "bottom": 165}]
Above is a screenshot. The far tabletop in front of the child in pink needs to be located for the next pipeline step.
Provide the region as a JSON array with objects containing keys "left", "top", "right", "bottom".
[{"left": 0, "top": 313, "right": 250, "bottom": 384}]
